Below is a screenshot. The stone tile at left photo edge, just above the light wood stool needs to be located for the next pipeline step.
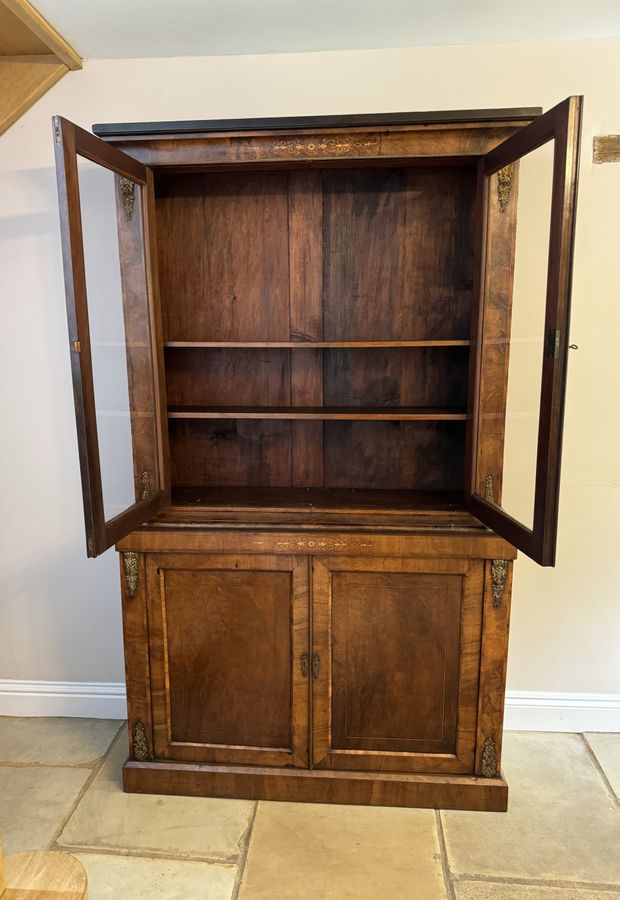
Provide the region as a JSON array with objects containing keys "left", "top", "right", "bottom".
[{"left": 0, "top": 766, "right": 91, "bottom": 854}]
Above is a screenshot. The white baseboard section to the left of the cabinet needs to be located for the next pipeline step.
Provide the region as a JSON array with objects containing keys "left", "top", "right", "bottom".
[{"left": 0, "top": 678, "right": 127, "bottom": 719}]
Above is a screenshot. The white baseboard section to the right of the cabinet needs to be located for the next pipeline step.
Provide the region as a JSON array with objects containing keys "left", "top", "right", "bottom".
[{"left": 504, "top": 691, "right": 620, "bottom": 731}]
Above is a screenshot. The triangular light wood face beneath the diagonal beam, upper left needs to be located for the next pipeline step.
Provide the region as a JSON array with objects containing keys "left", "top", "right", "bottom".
[{"left": 0, "top": 54, "right": 69, "bottom": 134}]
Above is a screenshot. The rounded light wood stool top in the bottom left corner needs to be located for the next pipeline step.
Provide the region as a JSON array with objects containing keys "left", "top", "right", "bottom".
[{"left": 0, "top": 844, "right": 88, "bottom": 900}]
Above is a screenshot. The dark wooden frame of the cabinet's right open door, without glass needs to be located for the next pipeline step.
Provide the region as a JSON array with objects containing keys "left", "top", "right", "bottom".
[{"left": 465, "top": 97, "right": 583, "bottom": 566}]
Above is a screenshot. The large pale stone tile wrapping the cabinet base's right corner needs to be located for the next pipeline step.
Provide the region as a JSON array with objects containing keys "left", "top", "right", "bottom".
[{"left": 442, "top": 732, "right": 620, "bottom": 885}]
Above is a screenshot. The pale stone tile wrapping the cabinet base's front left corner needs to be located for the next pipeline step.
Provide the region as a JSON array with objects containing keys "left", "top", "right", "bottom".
[{"left": 59, "top": 736, "right": 252, "bottom": 863}]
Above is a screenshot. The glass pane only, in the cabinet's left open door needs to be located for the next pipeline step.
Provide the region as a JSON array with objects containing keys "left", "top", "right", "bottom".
[{"left": 78, "top": 156, "right": 159, "bottom": 521}]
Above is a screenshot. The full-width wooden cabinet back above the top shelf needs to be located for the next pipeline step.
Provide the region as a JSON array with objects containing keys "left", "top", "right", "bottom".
[{"left": 157, "top": 166, "right": 475, "bottom": 342}]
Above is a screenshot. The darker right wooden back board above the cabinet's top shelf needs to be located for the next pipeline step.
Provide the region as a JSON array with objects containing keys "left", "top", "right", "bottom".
[{"left": 323, "top": 167, "right": 475, "bottom": 341}]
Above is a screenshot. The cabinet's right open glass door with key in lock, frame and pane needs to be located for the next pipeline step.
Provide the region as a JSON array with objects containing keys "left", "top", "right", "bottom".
[{"left": 467, "top": 97, "right": 581, "bottom": 566}]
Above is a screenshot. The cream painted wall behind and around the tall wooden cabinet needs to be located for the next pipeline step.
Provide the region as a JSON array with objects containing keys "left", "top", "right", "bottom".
[{"left": 0, "top": 40, "right": 620, "bottom": 694}]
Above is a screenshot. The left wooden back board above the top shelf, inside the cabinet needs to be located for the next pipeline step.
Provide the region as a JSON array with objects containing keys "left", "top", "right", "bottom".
[{"left": 157, "top": 172, "right": 290, "bottom": 341}]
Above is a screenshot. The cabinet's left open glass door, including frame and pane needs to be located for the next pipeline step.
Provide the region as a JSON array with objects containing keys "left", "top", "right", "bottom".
[{"left": 53, "top": 117, "right": 166, "bottom": 556}]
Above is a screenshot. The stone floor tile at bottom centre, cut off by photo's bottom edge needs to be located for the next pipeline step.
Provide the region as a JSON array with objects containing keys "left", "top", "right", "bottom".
[{"left": 239, "top": 803, "right": 446, "bottom": 900}]
